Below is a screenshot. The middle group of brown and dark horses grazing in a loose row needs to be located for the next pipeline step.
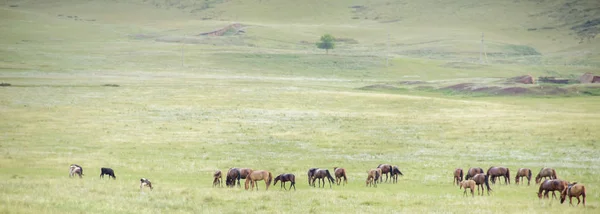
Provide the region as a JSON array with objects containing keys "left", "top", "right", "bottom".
[{"left": 213, "top": 164, "right": 403, "bottom": 190}]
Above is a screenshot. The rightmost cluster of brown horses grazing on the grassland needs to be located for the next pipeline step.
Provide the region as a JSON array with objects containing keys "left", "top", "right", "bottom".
[{"left": 453, "top": 166, "right": 586, "bottom": 207}]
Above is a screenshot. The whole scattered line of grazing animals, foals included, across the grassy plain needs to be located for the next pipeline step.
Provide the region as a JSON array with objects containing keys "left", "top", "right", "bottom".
[{"left": 69, "top": 164, "right": 586, "bottom": 207}]
